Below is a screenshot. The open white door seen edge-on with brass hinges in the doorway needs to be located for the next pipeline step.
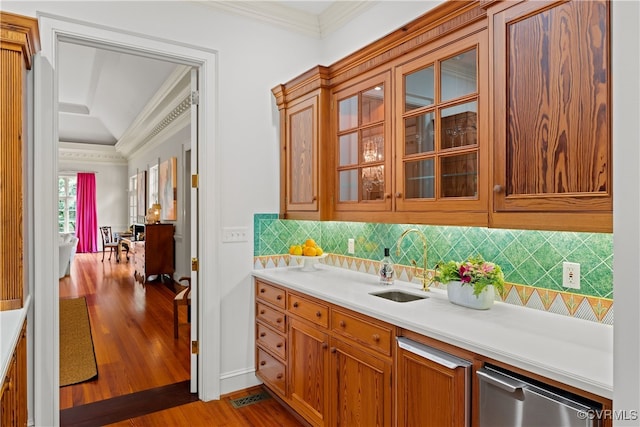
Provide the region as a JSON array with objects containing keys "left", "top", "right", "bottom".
[{"left": 189, "top": 68, "right": 199, "bottom": 393}]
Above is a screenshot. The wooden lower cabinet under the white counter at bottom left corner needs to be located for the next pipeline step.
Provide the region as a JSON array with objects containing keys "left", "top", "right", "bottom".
[{"left": 0, "top": 324, "right": 27, "bottom": 427}]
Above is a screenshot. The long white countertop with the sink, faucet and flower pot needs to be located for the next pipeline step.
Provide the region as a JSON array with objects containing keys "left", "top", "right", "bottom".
[{"left": 253, "top": 265, "right": 613, "bottom": 399}]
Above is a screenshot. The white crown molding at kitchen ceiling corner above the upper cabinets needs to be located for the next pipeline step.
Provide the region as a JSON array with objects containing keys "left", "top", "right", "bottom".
[{"left": 191, "top": 0, "right": 377, "bottom": 38}]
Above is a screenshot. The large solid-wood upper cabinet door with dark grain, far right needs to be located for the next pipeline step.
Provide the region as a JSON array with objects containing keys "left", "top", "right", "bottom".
[{"left": 488, "top": 0, "right": 612, "bottom": 232}]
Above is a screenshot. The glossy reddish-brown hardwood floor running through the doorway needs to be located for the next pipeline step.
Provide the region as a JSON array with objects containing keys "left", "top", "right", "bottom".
[{"left": 60, "top": 254, "right": 300, "bottom": 426}]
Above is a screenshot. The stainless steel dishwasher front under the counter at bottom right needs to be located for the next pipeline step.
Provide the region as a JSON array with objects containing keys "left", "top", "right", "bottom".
[{"left": 476, "top": 366, "right": 602, "bottom": 427}]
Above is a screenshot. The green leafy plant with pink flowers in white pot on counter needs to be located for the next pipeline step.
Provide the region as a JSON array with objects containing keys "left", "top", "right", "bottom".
[{"left": 435, "top": 255, "right": 504, "bottom": 296}]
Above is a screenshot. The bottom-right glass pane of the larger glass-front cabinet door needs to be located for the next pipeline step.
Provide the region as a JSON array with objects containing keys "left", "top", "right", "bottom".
[{"left": 440, "top": 151, "right": 478, "bottom": 197}]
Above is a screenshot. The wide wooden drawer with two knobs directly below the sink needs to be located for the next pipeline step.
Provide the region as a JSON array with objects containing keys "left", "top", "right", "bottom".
[{"left": 331, "top": 309, "right": 393, "bottom": 356}]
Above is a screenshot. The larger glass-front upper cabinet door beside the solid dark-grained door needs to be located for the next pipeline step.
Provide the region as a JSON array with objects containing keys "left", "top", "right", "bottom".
[{"left": 394, "top": 33, "right": 488, "bottom": 216}]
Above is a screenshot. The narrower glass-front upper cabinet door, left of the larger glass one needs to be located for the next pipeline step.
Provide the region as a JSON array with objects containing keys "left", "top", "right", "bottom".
[{"left": 332, "top": 73, "right": 391, "bottom": 211}]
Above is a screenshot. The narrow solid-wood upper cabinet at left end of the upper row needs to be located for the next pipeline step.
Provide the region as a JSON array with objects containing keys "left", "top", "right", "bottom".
[{"left": 272, "top": 67, "right": 331, "bottom": 220}]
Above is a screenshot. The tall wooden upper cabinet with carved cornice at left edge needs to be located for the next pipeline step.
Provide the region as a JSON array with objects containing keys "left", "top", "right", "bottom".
[{"left": 0, "top": 11, "right": 40, "bottom": 310}]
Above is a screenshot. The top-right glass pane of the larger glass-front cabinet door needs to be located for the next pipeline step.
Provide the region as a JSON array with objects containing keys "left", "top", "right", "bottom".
[{"left": 440, "top": 49, "right": 478, "bottom": 101}]
